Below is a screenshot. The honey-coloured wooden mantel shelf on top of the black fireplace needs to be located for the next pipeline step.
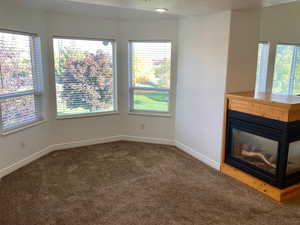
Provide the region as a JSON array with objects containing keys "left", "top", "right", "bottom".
[{"left": 226, "top": 92, "right": 300, "bottom": 122}]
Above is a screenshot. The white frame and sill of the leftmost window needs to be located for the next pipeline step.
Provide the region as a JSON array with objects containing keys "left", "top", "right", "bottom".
[{"left": 0, "top": 28, "right": 45, "bottom": 135}]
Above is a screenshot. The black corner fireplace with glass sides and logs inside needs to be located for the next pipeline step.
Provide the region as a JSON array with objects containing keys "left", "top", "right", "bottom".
[{"left": 225, "top": 110, "right": 300, "bottom": 189}]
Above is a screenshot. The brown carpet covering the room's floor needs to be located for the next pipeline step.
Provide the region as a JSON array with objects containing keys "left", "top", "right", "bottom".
[{"left": 0, "top": 141, "right": 300, "bottom": 225}]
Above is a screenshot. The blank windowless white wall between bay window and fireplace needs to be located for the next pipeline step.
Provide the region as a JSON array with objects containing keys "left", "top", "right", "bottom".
[{"left": 175, "top": 12, "right": 231, "bottom": 168}]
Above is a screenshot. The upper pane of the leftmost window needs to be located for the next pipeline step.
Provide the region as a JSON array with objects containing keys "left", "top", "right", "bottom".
[{"left": 0, "top": 32, "right": 33, "bottom": 94}]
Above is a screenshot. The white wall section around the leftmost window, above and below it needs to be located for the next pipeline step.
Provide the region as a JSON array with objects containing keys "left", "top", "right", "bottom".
[{"left": 0, "top": 5, "right": 50, "bottom": 170}]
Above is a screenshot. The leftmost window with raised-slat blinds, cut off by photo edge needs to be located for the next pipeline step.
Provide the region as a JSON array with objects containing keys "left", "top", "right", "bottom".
[{"left": 0, "top": 31, "right": 42, "bottom": 132}]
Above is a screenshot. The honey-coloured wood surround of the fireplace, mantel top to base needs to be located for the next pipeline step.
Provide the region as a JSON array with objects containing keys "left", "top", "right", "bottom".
[{"left": 221, "top": 92, "right": 300, "bottom": 202}]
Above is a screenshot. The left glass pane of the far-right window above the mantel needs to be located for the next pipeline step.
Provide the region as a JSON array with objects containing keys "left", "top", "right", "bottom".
[{"left": 272, "top": 45, "right": 294, "bottom": 95}]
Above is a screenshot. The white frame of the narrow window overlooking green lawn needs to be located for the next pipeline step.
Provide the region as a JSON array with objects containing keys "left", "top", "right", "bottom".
[{"left": 128, "top": 40, "right": 173, "bottom": 117}]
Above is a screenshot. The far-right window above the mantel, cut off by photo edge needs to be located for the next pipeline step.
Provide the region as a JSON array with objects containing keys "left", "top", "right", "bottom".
[{"left": 272, "top": 44, "right": 300, "bottom": 95}]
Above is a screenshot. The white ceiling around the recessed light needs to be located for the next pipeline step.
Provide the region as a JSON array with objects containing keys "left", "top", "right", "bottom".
[{"left": 10, "top": 0, "right": 295, "bottom": 19}]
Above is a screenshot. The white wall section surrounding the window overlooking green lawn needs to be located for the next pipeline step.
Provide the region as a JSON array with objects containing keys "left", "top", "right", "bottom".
[{"left": 120, "top": 20, "right": 177, "bottom": 141}]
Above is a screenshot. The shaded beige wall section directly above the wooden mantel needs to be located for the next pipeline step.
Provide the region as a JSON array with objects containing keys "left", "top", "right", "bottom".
[{"left": 226, "top": 10, "right": 260, "bottom": 92}]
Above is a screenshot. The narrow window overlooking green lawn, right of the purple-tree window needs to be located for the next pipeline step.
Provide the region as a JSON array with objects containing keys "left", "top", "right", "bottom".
[{"left": 129, "top": 41, "right": 171, "bottom": 112}]
